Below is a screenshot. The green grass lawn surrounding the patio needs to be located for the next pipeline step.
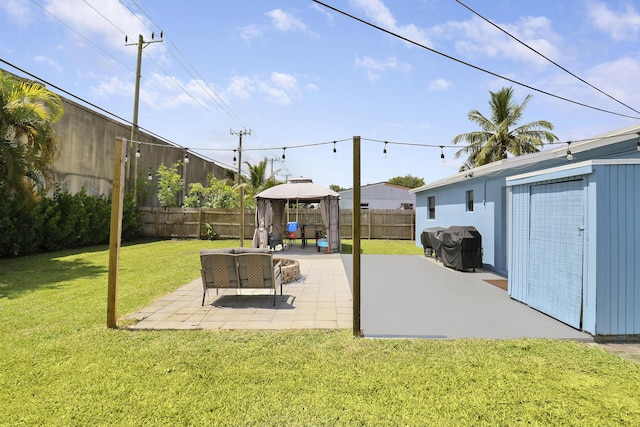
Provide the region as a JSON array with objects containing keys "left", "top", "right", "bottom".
[{"left": 0, "top": 241, "right": 640, "bottom": 426}]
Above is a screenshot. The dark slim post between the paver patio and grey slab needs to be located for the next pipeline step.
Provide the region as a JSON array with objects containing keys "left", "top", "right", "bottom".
[{"left": 351, "top": 136, "right": 362, "bottom": 337}]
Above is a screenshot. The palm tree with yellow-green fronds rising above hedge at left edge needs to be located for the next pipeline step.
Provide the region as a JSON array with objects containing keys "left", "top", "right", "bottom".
[{"left": 0, "top": 72, "right": 64, "bottom": 202}]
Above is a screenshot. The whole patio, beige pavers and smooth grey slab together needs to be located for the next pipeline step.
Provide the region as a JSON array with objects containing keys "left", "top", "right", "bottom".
[{"left": 125, "top": 246, "right": 593, "bottom": 341}]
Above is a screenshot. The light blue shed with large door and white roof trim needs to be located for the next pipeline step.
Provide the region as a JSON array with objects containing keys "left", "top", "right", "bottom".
[{"left": 507, "top": 159, "right": 640, "bottom": 337}]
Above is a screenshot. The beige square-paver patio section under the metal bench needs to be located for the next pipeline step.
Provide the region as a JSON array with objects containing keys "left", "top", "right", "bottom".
[{"left": 125, "top": 252, "right": 353, "bottom": 330}]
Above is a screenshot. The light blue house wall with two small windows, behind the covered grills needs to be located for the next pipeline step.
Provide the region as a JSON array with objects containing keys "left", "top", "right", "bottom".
[{"left": 416, "top": 177, "right": 507, "bottom": 275}]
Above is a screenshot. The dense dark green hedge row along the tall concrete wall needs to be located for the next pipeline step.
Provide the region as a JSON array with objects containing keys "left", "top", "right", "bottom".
[{"left": 0, "top": 188, "right": 142, "bottom": 257}]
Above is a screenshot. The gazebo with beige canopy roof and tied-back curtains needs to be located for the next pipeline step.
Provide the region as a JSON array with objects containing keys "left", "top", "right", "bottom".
[{"left": 253, "top": 178, "right": 340, "bottom": 253}]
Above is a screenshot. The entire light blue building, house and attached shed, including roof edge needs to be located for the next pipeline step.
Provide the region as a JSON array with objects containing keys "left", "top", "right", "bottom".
[{"left": 411, "top": 125, "right": 640, "bottom": 336}]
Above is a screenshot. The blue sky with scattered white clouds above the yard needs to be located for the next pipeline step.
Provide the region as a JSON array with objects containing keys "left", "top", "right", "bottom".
[{"left": 0, "top": 0, "right": 640, "bottom": 188}]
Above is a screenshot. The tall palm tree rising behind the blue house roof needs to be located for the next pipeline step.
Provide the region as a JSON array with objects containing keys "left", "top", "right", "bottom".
[{"left": 452, "top": 87, "right": 558, "bottom": 170}]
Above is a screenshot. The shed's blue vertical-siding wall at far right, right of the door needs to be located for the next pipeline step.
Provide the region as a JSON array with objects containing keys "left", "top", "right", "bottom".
[{"left": 594, "top": 165, "right": 640, "bottom": 335}]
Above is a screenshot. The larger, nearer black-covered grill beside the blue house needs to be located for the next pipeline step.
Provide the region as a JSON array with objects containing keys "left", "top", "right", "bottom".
[{"left": 436, "top": 226, "right": 482, "bottom": 270}]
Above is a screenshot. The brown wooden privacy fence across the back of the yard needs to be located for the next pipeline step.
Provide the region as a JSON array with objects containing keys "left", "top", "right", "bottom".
[{"left": 140, "top": 207, "right": 416, "bottom": 240}]
